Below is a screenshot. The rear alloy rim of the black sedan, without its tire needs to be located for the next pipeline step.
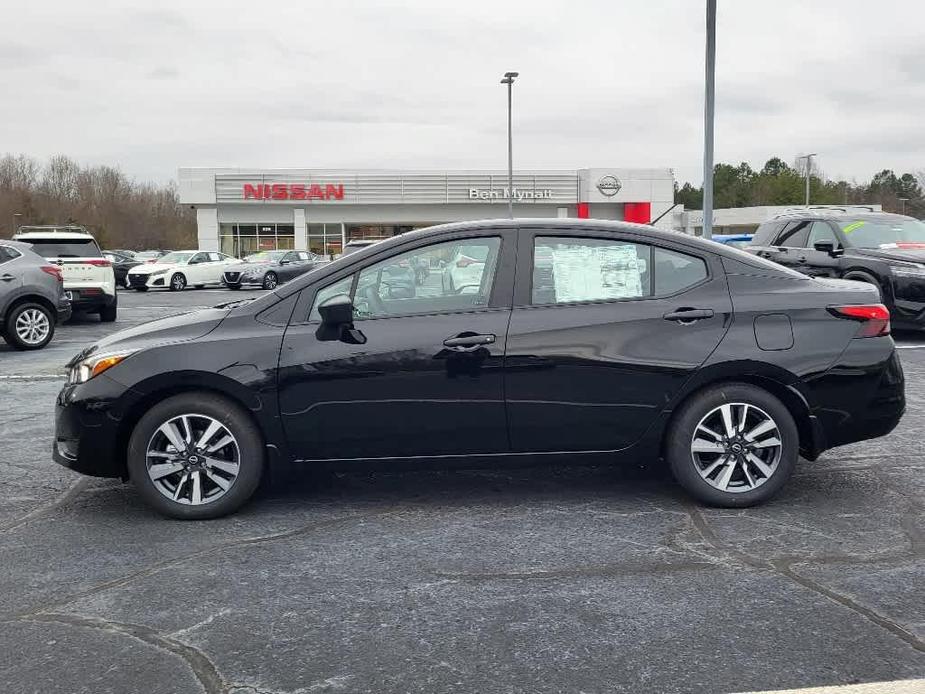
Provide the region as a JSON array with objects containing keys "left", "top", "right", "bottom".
[{"left": 690, "top": 402, "right": 783, "bottom": 494}]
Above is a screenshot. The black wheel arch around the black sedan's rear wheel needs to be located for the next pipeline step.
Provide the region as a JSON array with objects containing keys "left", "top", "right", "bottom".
[{"left": 659, "top": 362, "right": 821, "bottom": 460}]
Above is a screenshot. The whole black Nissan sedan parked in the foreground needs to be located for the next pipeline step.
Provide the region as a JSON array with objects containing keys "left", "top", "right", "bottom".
[{"left": 54, "top": 220, "right": 904, "bottom": 518}]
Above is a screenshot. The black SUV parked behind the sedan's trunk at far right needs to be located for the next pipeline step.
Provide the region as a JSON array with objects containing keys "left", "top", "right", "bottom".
[{"left": 746, "top": 207, "right": 925, "bottom": 329}]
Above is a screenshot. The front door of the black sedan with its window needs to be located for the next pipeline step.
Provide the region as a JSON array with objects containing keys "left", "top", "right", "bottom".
[{"left": 279, "top": 231, "right": 513, "bottom": 460}]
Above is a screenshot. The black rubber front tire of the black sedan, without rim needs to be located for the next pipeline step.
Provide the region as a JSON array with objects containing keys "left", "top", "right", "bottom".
[{"left": 127, "top": 392, "right": 265, "bottom": 520}]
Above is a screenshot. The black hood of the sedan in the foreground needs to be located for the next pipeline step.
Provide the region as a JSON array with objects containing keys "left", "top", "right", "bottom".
[{"left": 68, "top": 306, "right": 233, "bottom": 366}]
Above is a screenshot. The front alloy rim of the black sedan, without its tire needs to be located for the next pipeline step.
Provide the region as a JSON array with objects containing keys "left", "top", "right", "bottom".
[{"left": 146, "top": 413, "right": 241, "bottom": 506}]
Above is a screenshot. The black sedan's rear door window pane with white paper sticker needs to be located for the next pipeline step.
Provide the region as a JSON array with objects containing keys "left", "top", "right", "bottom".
[{"left": 533, "top": 237, "right": 652, "bottom": 304}]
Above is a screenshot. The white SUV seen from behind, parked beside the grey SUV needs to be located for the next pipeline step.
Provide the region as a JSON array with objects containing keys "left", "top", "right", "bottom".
[{"left": 13, "top": 226, "right": 118, "bottom": 323}]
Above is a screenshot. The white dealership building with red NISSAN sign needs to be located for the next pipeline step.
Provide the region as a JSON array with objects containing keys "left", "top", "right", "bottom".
[{"left": 179, "top": 168, "right": 677, "bottom": 256}]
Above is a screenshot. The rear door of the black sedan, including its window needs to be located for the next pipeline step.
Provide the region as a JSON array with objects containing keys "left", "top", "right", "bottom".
[{"left": 505, "top": 229, "right": 732, "bottom": 452}]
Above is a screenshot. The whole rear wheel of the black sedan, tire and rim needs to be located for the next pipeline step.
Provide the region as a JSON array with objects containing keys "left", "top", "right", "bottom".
[{"left": 666, "top": 383, "right": 800, "bottom": 508}]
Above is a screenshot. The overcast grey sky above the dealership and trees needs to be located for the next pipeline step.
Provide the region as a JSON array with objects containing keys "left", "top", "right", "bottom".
[{"left": 0, "top": 0, "right": 925, "bottom": 184}]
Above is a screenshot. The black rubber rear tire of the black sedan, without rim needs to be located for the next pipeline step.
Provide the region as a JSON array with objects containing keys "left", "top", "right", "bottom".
[{"left": 665, "top": 383, "right": 800, "bottom": 508}]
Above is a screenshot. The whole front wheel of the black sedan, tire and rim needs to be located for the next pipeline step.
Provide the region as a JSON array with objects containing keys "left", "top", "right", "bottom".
[{"left": 128, "top": 392, "right": 264, "bottom": 520}]
